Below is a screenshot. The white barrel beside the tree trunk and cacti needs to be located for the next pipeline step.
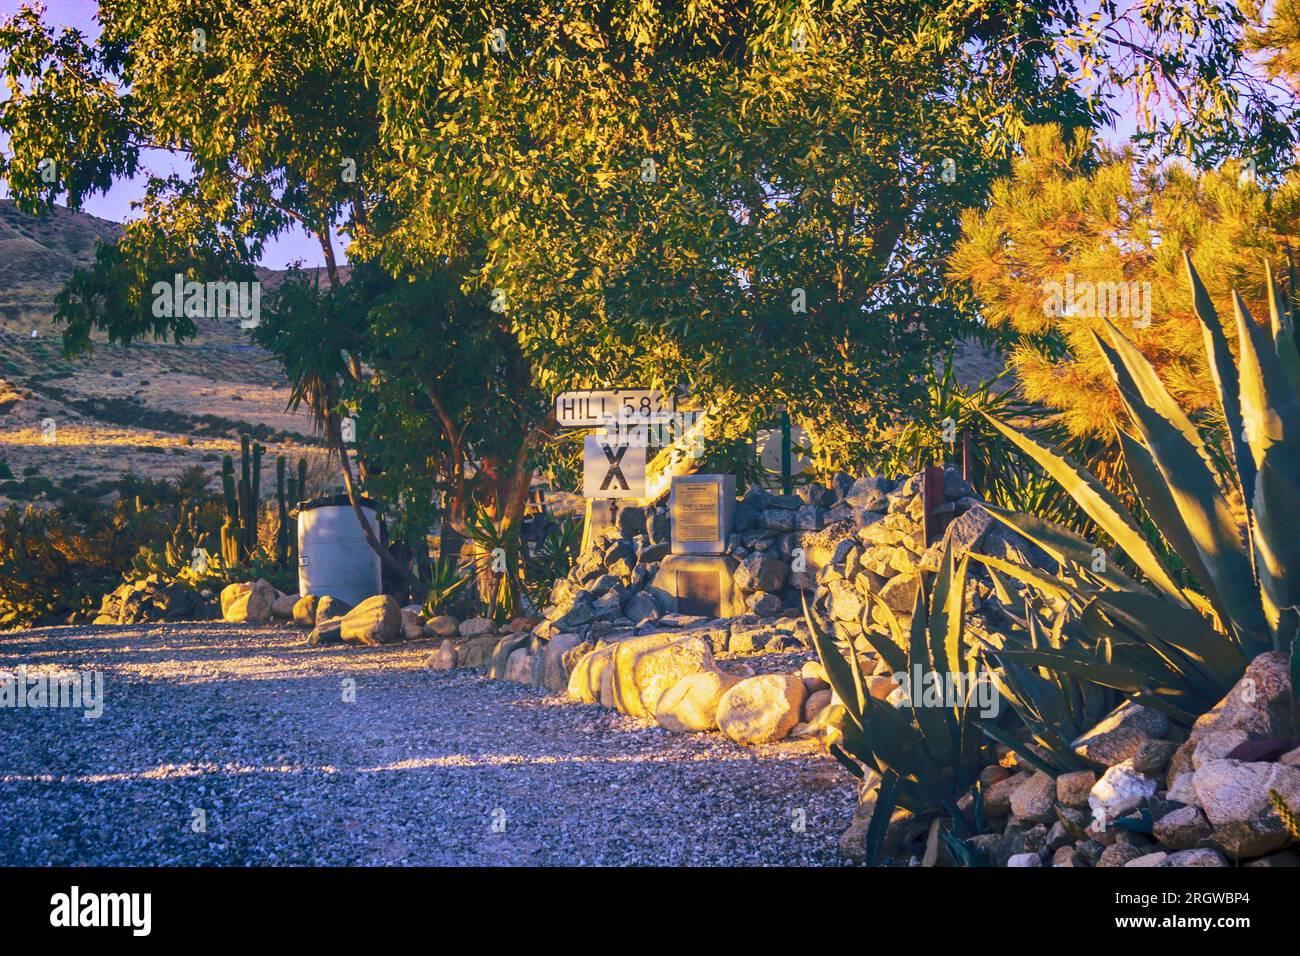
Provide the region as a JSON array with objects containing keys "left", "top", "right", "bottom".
[{"left": 298, "top": 496, "right": 382, "bottom": 607}]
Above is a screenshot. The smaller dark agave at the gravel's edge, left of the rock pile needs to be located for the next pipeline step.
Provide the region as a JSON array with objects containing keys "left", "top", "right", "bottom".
[{"left": 803, "top": 548, "right": 989, "bottom": 862}]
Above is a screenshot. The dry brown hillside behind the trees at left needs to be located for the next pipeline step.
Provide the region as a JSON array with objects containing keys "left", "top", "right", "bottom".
[{"left": 0, "top": 200, "right": 326, "bottom": 507}]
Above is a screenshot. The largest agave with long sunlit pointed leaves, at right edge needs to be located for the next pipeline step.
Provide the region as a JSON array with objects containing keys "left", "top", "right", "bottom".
[{"left": 976, "top": 255, "right": 1300, "bottom": 722}]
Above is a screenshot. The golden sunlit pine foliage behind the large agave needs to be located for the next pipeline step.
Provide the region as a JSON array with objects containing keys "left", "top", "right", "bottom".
[{"left": 949, "top": 126, "right": 1300, "bottom": 438}]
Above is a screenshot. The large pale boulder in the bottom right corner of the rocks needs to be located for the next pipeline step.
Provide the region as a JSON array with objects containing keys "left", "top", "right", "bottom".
[{"left": 1192, "top": 760, "right": 1300, "bottom": 860}]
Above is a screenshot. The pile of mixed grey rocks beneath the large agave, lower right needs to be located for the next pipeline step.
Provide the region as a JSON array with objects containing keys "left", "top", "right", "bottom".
[{"left": 840, "top": 653, "right": 1300, "bottom": 866}]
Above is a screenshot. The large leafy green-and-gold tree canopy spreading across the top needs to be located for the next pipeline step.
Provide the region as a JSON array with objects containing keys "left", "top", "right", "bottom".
[{"left": 0, "top": 0, "right": 1288, "bottom": 606}]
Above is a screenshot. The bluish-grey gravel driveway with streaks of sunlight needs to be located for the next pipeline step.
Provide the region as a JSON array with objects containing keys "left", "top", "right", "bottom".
[{"left": 0, "top": 623, "right": 853, "bottom": 865}]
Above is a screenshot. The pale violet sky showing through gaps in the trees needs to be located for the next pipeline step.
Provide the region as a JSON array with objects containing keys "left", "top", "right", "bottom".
[{"left": 0, "top": 0, "right": 1134, "bottom": 269}]
